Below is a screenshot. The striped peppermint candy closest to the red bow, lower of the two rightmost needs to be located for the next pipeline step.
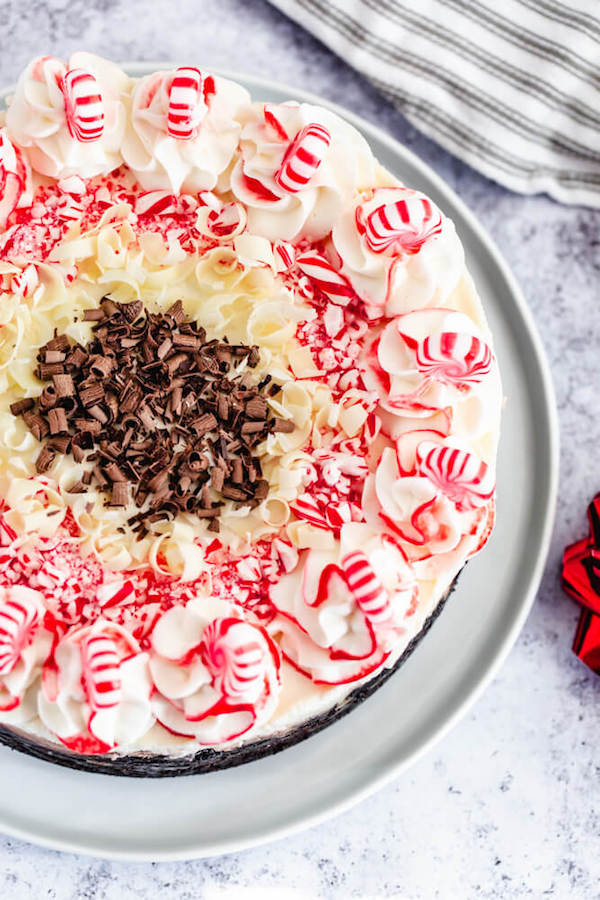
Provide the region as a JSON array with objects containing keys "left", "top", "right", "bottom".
[{"left": 416, "top": 441, "right": 495, "bottom": 510}]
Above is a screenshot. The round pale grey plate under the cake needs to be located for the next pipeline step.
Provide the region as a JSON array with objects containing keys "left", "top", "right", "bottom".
[{"left": 0, "top": 63, "right": 558, "bottom": 860}]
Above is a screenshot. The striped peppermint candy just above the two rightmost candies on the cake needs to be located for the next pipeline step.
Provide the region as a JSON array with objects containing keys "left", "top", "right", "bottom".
[{"left": 365, "top": 197, "right": 442, "bottom": 253}]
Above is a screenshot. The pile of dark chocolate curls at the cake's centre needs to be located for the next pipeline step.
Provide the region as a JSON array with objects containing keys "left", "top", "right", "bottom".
[{"left": 10, "top": 298, "right": 294, "bottom": 534}]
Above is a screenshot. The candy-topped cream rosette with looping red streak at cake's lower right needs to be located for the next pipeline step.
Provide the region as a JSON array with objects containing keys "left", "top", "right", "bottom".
[{"left": 270, "top": 524, "right": 419, "bottom": 684}]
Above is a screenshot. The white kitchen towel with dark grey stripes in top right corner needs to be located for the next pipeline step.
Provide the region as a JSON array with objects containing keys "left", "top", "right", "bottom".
[{"left": 272, "top": 0, "right": 600, "bottom": 207}]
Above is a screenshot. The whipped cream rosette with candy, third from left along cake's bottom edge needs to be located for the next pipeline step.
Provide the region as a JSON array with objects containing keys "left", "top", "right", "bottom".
[{"left": 150, "top": 596, "right": 281, "bottom": 745}]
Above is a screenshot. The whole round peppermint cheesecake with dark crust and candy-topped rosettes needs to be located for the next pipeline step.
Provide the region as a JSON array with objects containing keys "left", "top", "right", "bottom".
[{"left": 0, "top": 53, "right": 502, "bottom": 775}]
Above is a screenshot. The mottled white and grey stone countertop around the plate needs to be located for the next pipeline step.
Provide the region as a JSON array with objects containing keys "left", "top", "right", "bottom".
[{"left": 0, "top": 0, "right": 600, "bottom": 900}]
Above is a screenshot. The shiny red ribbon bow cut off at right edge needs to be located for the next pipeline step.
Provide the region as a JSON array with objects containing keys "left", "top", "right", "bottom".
[{"left": 562, "top": 493, "right": 600, "bottom": 675}]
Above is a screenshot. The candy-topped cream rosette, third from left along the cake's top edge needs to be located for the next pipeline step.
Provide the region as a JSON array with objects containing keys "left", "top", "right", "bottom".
[{"left": 231, "top": 103, "right": 375, "bottom": 241}]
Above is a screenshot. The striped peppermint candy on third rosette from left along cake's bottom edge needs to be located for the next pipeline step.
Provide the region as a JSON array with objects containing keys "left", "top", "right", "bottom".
[{"left": 200, "top": 618, "right": 265, "bottom": 702}]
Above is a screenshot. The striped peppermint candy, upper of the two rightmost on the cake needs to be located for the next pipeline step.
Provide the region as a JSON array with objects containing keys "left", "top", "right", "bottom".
[{"left": 416, "top": 331, "right": 492, "bottom": 385}]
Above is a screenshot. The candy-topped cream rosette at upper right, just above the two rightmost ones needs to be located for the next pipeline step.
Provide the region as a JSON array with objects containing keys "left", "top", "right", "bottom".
[{"left": 332, "top": 187, "right": 464, "bottom": 316}]
